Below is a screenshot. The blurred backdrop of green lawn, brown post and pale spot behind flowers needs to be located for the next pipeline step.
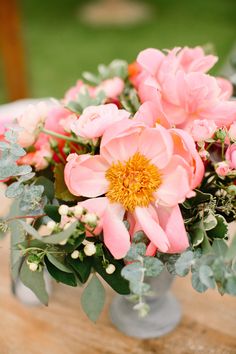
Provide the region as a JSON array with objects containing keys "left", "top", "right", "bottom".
[{"left": 0, "top": 0, "right": 236, "bottom": 103}]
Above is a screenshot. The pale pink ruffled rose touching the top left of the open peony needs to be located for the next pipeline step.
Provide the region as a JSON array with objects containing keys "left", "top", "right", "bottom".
[{"left": 71, "top": 103, "right": 130, "bottom": 139}]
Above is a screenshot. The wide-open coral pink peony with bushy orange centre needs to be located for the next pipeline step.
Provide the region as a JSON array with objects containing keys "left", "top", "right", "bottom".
[{"left": 65, "top": 119, "right": 203, "bottom": 259}]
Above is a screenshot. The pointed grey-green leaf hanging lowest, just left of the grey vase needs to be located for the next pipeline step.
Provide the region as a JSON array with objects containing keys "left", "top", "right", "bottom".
[{"left": 81, "top": 274, "right": 105, "bottom": 322}]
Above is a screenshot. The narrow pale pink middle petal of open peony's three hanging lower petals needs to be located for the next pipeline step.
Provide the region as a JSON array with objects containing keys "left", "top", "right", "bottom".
[{"left": 134, "top": 207, "right": 170, "bottom": 252}]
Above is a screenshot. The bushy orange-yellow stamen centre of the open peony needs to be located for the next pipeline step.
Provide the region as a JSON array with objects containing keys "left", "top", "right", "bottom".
[{"left": 106, "top": 152, "right": 162, "bottom": 211}]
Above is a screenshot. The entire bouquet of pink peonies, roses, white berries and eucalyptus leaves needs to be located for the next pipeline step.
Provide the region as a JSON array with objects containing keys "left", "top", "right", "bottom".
[{"left": 0, "top": 47, "right": 236, "bottom": 321}]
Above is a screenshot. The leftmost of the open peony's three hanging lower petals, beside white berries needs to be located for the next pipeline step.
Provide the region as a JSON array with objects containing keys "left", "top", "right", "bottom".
[{"left": 103, "top": 204, "right": 130, "bottom": 259}]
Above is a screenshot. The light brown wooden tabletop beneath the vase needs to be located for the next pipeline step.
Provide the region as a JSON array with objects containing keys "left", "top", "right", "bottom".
[{"left": 0, "top": 239, "right": 236, "bottom": 354}]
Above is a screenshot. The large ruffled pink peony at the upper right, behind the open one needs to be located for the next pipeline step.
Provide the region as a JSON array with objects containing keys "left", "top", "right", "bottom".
[{"left": 136, "top": 47, "right": 236, "bottom": 129}]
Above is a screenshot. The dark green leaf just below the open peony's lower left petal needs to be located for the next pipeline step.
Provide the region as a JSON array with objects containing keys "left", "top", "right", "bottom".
[{"left": 93, "top": 253, "right": 130, "bottom": 295}]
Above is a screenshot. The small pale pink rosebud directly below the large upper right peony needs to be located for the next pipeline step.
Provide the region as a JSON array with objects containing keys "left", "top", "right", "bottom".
[{"left": 189, "top": 119, "right": 217, "bottom": 141}]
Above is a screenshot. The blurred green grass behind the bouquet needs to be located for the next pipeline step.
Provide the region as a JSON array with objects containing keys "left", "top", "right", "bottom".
[{"left": 0, "top": 0, "right": 236, "bottom": 102}]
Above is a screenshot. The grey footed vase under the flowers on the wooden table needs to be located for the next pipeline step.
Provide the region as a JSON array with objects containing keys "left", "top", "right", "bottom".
[{"left": 110, "top": 270, "right": 181, "bottom": 339}]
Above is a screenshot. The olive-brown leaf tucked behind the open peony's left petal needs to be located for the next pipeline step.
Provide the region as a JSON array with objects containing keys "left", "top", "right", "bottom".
[{"left": 54, "top": 164, "right": 78, "bottom": 202}]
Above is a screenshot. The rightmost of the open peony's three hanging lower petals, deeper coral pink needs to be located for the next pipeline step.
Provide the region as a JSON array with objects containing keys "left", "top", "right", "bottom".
[{"left": 157, "top": 205, "right": 189, "bottom": 253}]
